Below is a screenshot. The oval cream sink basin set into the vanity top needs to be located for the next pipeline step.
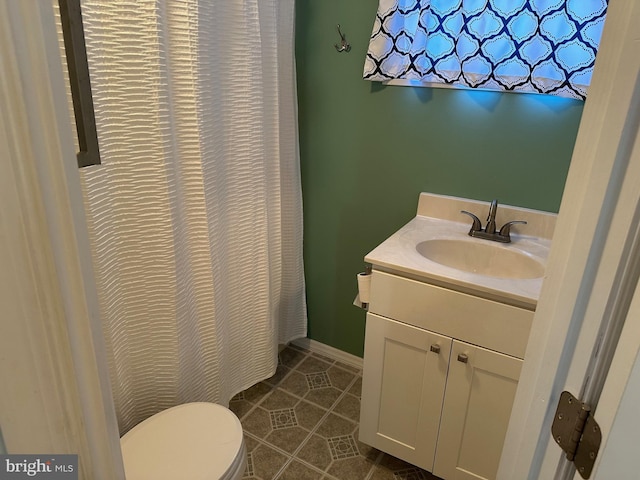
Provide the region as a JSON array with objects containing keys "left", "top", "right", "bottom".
[{"left": 416, "top": 239, "right": 544, "bottom": 279}]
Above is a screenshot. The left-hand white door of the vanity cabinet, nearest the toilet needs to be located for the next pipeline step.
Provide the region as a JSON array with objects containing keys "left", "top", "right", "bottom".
[{"left": 360, "top": 313, "right": 451, "bottom": 471}]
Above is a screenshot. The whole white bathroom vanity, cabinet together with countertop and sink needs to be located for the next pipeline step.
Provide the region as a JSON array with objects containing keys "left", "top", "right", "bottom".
[{"left": 360, "top": 194, "right": 555, "bottom": 480}]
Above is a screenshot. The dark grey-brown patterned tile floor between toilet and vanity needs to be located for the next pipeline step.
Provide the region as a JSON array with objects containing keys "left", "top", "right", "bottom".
[{"left": 229, "top": 346, "right": 439, "bottom": 480}]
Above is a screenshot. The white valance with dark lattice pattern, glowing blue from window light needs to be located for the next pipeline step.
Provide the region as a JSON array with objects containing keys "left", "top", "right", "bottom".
[{"left": 364, "top": 0, "right": 607, "bottom": 100}]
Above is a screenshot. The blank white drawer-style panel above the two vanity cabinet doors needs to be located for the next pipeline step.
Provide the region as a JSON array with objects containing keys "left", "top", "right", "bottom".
[{"left": 369, "top": 271, "right": 533, "bottom": 358}]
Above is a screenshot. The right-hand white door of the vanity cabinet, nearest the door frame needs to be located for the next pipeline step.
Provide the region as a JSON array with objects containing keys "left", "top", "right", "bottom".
[{"left": 433, "top": 340, "right": 522, "bottom": 480}]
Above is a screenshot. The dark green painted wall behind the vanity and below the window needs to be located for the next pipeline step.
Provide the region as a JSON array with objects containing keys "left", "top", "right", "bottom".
[{"left": 296, "top": 0, "right": 583, "bottom": 356}]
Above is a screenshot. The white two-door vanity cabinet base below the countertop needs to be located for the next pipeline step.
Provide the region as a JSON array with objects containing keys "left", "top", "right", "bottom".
[{"left": 360, "top": 270, "right": 533, "bottom": 480}]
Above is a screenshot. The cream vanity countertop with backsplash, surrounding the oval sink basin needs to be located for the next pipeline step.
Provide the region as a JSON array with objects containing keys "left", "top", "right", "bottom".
[{"left": 365, "top": 193, "right": 556, "bottom": 310}]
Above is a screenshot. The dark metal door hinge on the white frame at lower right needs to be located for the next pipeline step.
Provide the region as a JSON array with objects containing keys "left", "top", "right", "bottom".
[{"left": 551, "top": 392, "right": 602, "bottom": 479}]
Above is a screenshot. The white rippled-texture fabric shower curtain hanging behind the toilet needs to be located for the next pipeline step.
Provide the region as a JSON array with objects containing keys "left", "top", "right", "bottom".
[{"left": 75, "top": 0, "right": 306, "bottom": 433}]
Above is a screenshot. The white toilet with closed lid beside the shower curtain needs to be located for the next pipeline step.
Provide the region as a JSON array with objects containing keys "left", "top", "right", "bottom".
[{"left": 120, "top": 402, "right": 247, "bottom": 480}]
